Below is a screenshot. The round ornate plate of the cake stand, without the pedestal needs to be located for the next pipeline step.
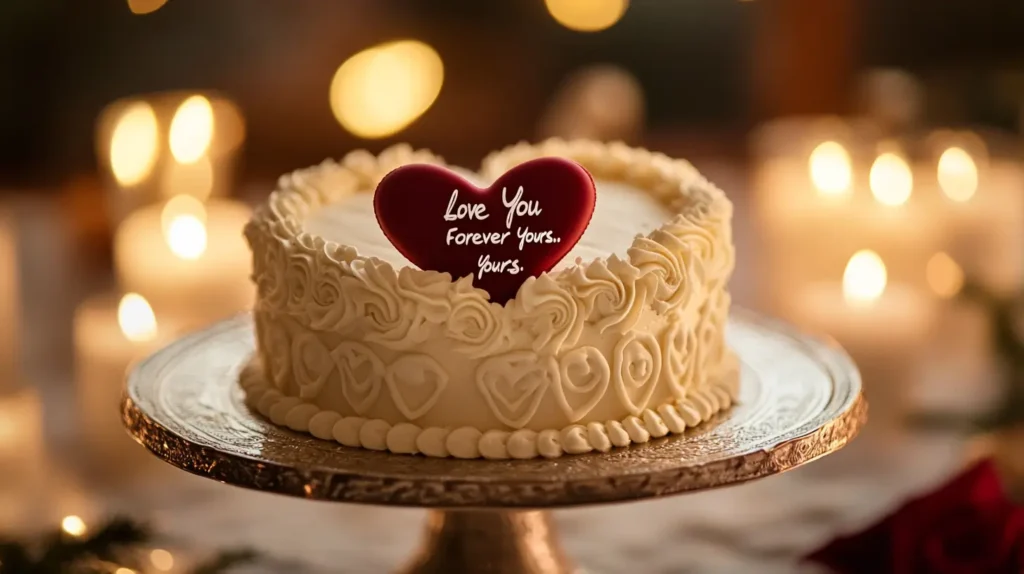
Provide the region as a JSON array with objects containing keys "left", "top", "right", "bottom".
[{"left": 122, "top": 310, "right": 867, "bottom": 509}]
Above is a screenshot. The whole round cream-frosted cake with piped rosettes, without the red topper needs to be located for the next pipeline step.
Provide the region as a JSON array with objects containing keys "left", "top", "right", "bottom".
[{"left": 240, "top": 140, "right": 738, "bottom": 458}]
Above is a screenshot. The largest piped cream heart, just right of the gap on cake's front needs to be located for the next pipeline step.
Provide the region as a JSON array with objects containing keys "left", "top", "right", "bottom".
[{"left": 476, "top": 351, "right": 558, "bottom": 429}]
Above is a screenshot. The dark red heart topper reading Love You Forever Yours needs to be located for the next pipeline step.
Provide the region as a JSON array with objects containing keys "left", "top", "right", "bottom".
[{"left": 374, "top": 158, "right": 597, "bottom": 304}]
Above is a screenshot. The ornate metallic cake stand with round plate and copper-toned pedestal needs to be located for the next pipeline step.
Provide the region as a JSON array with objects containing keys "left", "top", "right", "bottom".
[{"left": 122, "top": 311, "right": 867, "bottom": 574}]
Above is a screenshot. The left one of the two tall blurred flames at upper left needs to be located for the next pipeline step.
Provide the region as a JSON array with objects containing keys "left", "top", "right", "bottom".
[{"left": 111, "top": 101, "right": 160, "bottom": 186}]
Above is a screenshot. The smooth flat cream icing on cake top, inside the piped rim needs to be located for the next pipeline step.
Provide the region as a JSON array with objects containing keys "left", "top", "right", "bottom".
[{"left": 303, "top": 178, "right": 673, "bottom": 269}]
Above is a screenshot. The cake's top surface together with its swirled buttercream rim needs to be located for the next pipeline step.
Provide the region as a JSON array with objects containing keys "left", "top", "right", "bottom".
[{"left": 246, "top": 139, "right": 735, "bottom": 313}]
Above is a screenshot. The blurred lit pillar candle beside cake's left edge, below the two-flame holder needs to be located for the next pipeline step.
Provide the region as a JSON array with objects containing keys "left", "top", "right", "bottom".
[{"left": 114, "top": 196, "right": 254, "bottom": 326}]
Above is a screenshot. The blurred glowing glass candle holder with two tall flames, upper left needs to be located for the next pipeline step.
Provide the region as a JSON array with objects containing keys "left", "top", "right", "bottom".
[{"left": 96, "top": 92, "right": 245, "bottom": 221}]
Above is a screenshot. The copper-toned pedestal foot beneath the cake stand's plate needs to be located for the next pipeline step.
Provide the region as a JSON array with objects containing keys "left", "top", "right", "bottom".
[{"left": 401, "top": 511, "right": 575, "bottom": 574}]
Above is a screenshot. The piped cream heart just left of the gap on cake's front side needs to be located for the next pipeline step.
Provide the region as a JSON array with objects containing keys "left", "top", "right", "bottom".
[{"left": 384, "top": 355, "right": 449, "bottom": 421}]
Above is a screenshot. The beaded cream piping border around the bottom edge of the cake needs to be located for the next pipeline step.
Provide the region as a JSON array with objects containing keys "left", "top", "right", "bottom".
[{"left": 239, "top": 355, "right": 739, "bottom": 459}]
